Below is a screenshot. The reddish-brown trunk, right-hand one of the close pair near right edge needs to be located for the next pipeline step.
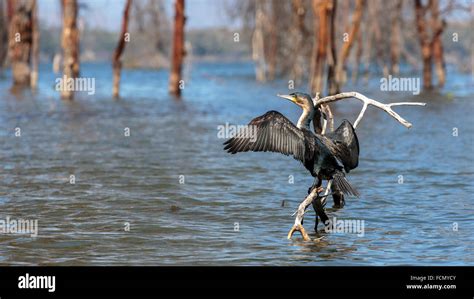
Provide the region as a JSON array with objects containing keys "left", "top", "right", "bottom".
[{"left": 429, "top": 0, "right": 446, "bottom": 87}]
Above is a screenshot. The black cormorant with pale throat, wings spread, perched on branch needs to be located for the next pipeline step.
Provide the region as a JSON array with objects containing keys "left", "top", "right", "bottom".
[{"left": 224, "top": 92, "right": 359, "bottom": 239}]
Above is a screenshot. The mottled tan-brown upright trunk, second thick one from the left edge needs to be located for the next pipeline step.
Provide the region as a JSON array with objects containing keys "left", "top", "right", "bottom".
[{"left": 61, "top": 0, "right": 79, "bottom": 100}]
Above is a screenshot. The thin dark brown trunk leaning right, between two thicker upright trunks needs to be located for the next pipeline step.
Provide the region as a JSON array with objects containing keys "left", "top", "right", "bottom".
[{"left": 112, "top": 0, "right": 132, "bottom": 98}]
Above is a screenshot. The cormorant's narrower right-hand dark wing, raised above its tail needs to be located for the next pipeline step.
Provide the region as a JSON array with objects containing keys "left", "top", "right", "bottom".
[{"left": 325, "top": 119, "right": 359, "bottom": 172}]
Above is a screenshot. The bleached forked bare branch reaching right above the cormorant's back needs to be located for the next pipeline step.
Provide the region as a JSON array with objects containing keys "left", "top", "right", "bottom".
[{"left": 313, "top": 92, "right": 426, "bottom": 128}]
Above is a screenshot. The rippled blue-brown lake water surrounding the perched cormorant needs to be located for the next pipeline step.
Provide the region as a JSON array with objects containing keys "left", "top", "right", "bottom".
[{"left": 0, "top": 63, "right": 474, "bottom": 266}]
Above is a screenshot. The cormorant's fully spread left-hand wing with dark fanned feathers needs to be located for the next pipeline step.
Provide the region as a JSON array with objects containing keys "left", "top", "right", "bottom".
[{"left": 224, "top": 111, "right": 318, "bottom": 169}]
